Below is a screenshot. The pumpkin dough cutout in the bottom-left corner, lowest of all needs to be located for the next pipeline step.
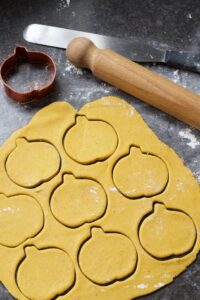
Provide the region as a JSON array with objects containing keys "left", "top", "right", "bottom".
[{"left": 16, "top": 246, "right": 75, "bottom": 300}]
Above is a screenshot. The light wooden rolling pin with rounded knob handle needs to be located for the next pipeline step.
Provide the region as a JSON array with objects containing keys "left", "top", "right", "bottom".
[{"left": 67, "top": 38, "right": 200, "bottom": 130}]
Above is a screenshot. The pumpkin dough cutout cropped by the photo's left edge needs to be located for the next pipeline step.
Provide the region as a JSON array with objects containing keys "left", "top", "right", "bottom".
[{"left": 0, "top": 194, "right": 44, "bottom": 247}]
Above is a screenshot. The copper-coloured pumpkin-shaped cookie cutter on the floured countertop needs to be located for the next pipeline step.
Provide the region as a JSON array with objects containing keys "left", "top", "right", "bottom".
[{"left": 0, "top": 46, "right": 56, "bottom": 102}]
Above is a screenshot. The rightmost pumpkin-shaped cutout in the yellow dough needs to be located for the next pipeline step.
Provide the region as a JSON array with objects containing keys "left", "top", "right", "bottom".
[{"left": 139, "top": 203, "right": 196, "bottom": 259}]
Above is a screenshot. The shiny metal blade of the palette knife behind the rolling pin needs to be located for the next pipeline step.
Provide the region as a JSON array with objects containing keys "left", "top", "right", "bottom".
[{"left": 23, "top": 24, "right": 166, "bottom": 62}]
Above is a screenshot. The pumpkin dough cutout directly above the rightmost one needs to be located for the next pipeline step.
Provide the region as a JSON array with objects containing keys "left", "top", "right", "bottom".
[{"left": 113, "top": 147, "right": 168, "bottom": 198}]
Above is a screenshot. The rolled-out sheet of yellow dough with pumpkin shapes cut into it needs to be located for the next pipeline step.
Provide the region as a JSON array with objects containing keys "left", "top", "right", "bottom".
[{"left": 0, "top": 97, "right": 200, "bottom": 300}]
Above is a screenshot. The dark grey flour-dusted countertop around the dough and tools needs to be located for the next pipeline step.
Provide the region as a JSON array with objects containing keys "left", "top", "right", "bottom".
[{"left": 0, "top": 0, "right": 200, "bottom": 300}]
